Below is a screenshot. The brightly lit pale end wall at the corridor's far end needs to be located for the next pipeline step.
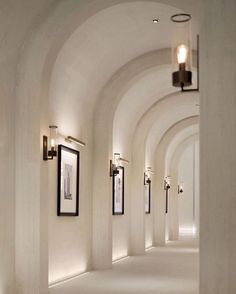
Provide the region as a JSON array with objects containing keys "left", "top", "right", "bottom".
[{"left": 178, "top": 143, "right": 199, "bottom": 235}]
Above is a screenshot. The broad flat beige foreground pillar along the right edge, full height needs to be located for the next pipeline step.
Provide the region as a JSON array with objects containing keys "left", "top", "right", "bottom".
[{"left": 200, "top": 0, "right": 236, "bottom": 294}]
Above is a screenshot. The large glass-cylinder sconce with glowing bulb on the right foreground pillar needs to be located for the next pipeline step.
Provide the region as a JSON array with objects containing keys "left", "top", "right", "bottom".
[{"left": 171, "top": 13, "right": 199, "bottom": 92}]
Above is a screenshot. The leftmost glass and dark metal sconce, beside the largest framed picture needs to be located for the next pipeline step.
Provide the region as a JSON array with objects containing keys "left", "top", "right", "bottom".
[{"left": 43, "top": 126, "right": 57, "bottom": 160}]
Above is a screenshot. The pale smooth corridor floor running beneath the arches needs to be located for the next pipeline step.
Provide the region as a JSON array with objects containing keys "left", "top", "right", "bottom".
[{"left": 50, "top": 239, "right": 199, "bottom": 294}]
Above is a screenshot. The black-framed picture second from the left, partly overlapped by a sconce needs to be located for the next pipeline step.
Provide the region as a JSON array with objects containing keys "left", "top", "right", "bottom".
[{"left": 112, "top": 166, "right": 124, "bottom": 215}]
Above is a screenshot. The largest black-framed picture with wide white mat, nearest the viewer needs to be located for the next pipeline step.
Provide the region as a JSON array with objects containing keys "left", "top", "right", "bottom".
[{"left": 57, "top": 145, "right": 80, "bottom": 216}]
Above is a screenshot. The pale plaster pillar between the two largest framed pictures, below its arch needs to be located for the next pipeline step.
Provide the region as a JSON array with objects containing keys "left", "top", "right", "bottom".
[{"left": 92, "top": 121, "right": 112, "bottom": 269}]
